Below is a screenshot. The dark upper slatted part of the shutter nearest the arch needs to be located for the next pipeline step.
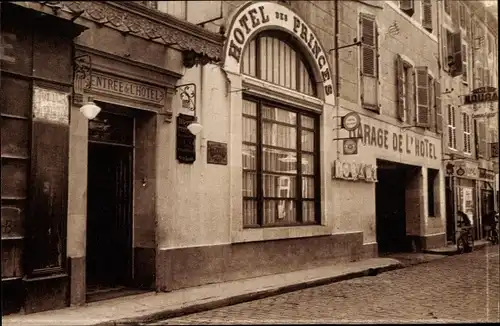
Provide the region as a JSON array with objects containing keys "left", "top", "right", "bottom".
[{"left": 360, "top": 14, "right": 377, "bottom": 77}]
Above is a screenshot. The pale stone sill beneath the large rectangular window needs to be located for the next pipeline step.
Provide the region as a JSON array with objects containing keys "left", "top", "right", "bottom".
[{"left": 231, "top": 225, "right": 333, "bottom": 243}]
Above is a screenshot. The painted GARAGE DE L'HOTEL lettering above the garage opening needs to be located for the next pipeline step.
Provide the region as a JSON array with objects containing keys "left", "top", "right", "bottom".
[{"left": 349, "top": 123, "right": 438, "bottom": 160}]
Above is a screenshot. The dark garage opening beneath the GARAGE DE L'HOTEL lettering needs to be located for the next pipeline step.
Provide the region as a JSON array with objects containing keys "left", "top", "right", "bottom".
[{"left": 375, "top": 160, "right": 415, "bottom": 253}]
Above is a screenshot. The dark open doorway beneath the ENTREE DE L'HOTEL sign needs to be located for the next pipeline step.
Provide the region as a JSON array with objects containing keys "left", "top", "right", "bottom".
[{"left": 86, "top": 112, "right": 134, "bottom": 301}]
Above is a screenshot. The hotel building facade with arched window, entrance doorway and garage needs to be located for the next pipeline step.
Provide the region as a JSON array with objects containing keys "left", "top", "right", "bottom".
[{"left": 1, "top": 0, "right": 496, "bottom": 313}]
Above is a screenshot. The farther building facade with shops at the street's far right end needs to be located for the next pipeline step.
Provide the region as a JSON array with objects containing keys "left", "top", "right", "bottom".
[{"left": 440, "top": 1, "right": 498, "bottom": 243}]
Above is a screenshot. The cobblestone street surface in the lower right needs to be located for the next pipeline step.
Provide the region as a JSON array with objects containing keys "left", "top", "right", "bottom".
[{"left": 152, "top": 246, "right": 500, "bottom": 325}]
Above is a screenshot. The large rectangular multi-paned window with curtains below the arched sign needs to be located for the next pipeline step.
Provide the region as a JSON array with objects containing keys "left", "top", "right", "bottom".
[{"left": 242, "top": 98, "right": 320, "bottom": 227}]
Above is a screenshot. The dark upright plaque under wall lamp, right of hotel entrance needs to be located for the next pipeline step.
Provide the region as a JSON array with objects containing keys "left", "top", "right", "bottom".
[{"left": 176, "top": 114, "right": 196, "bottom": 164}]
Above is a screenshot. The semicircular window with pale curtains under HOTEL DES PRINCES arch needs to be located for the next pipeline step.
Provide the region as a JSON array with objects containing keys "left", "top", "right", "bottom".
[{"left": 241, "top": 31, "right": 317, "bottom": 96}]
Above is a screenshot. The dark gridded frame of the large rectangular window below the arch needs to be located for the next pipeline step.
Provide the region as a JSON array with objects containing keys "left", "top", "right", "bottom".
[{"left": 241, "top": 93, "right": 321, "bottom": 229}]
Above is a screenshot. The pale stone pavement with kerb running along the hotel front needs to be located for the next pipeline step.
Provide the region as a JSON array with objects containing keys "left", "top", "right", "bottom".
[{"left": 2, "top": 258, "right": 403, "bottom": 326}]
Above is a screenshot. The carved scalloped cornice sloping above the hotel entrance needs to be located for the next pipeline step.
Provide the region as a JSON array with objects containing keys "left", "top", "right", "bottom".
[{"left": 20, "top": 1, "right": 225, "bottom": 62}]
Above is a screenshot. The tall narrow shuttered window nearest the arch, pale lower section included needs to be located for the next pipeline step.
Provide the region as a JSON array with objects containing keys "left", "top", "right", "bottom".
[{"left": 359, "top": 13, "right": 379, "bottom": 112}]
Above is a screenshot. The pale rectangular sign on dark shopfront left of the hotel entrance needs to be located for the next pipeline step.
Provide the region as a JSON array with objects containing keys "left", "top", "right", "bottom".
[{"left": 33, "top": 86, "right": 69, "bottom": 125}]
